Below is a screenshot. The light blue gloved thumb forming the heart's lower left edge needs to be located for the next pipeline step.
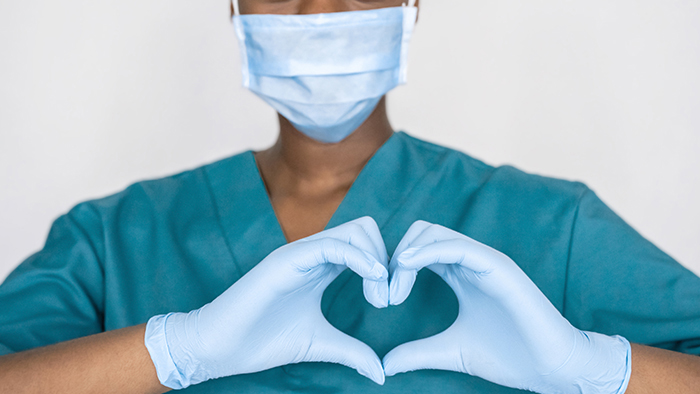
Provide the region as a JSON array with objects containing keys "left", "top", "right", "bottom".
[{"left": 302, "top": 322, "right": 384, "bottom": 384}]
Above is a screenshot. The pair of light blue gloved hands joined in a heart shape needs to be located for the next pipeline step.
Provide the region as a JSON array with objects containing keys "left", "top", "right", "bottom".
[{"left": 145, "top": 217, "right": 629, "bottom": 392}]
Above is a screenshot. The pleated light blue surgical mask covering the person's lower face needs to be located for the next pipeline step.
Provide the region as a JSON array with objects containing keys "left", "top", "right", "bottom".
[{"left": 233, "top": 0, "right": 418, "bottom": 143}]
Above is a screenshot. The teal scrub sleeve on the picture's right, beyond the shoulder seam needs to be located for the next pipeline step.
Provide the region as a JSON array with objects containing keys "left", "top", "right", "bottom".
[{"left": 564, "top": 190, "right": 700, "bottom": 355}]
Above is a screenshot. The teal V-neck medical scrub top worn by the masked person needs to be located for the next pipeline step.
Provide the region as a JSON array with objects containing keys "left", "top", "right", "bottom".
[{"left": 0, "top": 133, "right": 700, "bottom": 394}]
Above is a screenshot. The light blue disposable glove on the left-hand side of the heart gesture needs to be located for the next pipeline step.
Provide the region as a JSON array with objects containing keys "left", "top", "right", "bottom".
[{"left": 145, "top": 217, "right": 389, "bottom": 389}]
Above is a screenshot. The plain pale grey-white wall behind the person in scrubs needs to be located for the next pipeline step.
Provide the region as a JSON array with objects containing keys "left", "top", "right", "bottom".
[{"left": 0, "top": 0, "right": 700, "bottom": 280}]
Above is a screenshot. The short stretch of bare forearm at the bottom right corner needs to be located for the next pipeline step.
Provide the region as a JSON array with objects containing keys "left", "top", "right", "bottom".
[{"left": 625, "top": 344, "right": 700, "bottom": 394}]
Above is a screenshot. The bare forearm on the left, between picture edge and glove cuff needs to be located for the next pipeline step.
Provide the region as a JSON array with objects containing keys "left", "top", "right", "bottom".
[{"left": 0, "top": 324, "right": 169, "bottom": 394}]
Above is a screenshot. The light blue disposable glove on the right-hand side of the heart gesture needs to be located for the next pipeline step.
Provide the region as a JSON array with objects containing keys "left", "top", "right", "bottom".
[{"left": 384, "top": 221, "right": 631, "bottom": 393}]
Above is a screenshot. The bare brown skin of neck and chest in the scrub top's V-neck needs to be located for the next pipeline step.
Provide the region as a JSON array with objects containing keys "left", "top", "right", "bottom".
[{"left": 255, "top": 99, "right": 394, "bottom": 242}]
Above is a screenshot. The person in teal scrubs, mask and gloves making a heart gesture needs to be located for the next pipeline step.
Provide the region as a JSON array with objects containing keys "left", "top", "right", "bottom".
[{"left": 0, "top": 0, "right": 700, "bottom": 393}]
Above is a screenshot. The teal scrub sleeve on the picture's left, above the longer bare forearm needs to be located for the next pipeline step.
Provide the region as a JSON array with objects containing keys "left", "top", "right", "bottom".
[{"left": 0, "top": 204, "right": 104, "bottom": 354}]
